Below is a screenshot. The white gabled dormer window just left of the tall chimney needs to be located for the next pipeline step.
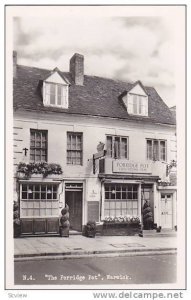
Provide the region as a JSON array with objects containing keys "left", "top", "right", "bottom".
[{"left": 43, "top": 69, "right": 69, "bottom": 108}]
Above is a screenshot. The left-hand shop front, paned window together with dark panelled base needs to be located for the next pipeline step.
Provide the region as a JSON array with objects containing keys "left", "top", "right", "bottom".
[{"left": 19, "top": 181, "right": 60, "bottom": 234}]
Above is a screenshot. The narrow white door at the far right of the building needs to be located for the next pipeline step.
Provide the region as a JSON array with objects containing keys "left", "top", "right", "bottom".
[{"left": 161, "top": 194, "right": 172, "bottom": 229}]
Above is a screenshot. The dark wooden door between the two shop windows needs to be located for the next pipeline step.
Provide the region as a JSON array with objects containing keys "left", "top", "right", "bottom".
[{"left": 65, "top": 191, "right": 82, "bottom": 231}]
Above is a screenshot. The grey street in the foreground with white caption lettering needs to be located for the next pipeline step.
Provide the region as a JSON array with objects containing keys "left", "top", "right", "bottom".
[{"left": 15, "top": 254, "right": 176, "bottom": 285}]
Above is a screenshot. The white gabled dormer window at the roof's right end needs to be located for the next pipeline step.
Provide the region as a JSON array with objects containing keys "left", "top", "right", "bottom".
[{"left": 122, "top": 81, "right": 148, "bottom": 117}]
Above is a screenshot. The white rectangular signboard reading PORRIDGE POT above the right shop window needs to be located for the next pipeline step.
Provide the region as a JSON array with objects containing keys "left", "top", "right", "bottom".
[{"left": 113, "top": 159, "right": 152, "bottom": 174}]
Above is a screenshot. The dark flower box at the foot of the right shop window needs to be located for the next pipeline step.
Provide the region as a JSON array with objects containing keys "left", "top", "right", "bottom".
[{"left": 101, "top": 222, "right": 141, "bottom": 236}]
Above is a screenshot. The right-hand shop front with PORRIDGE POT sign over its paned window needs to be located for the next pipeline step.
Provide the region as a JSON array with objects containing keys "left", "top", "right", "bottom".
[{"left": 98, "top": 157, "right": 164, "bottom": 226}]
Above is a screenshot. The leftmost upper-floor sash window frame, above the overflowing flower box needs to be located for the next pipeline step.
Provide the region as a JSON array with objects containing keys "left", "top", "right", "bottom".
[{"left": 30, "top": 128, "right": 48, "bottom": 162}]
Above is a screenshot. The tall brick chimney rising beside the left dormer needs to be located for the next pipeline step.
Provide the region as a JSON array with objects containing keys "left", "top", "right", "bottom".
[{"left": 70, "top": 53, "right": 84, "bottom": 85}]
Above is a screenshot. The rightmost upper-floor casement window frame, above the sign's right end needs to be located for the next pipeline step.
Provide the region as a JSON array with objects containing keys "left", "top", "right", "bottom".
[{"left": 146, "top": 138, "right": 167, "bottom": 162}]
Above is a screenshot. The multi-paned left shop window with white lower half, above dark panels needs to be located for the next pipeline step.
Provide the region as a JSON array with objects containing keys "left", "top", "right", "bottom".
[{"left": 20, "top": 183, "right": 59, "bottom": 217}]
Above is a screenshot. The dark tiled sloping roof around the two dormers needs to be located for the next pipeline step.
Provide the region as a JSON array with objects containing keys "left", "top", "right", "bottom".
[{"left": 13, "top": 65, "right": 176, "bottom": 125}]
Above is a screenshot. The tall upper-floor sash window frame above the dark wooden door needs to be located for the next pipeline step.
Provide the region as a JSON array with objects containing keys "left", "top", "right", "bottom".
[{"left": 66, "top": 131, "right": 83, "bottom": 166}]
